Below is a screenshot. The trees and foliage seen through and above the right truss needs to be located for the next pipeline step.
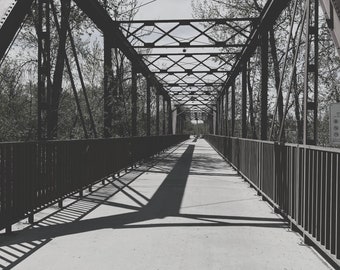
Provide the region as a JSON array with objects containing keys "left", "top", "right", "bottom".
[{"left": 192, "top": 0, "right": 340, "bottom": 145}]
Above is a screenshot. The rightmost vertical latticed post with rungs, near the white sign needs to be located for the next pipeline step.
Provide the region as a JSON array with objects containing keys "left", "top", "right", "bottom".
[{"left": 303, "top": 0, "right": 319, "bottom": 145}]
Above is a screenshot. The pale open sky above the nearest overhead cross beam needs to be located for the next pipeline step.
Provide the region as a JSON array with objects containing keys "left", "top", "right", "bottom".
[{"left": 135, "top": 0, "right": 192, "bottom": 20}]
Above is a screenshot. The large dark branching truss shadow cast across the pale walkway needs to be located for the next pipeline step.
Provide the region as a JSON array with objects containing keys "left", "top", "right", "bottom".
[{"left": 0, "top": 144, "right": 287, "bottom": 269}]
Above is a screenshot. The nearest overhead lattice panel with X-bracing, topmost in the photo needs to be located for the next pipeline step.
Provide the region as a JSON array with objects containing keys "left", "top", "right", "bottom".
[{"left": 120, "top": 18, "right": 253, "bottom": 48}]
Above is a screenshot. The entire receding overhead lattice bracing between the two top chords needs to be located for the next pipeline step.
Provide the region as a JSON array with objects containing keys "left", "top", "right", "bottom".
[{"left": 118, "top": 18, "right": 257, "bottom": 110}]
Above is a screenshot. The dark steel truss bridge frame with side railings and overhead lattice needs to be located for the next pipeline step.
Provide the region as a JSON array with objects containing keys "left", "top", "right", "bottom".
[{"left": 0, "top": 0, "right": 340, "bottom": 266}]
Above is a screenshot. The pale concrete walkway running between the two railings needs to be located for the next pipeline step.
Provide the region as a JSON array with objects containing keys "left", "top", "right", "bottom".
[{"left": 0, "top": 140, "right": 331, "bottom": 270}]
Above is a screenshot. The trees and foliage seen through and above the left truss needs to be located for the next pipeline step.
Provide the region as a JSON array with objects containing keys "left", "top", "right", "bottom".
[{"left": 0, "top": 0, "right": 170, "bottom": 141}]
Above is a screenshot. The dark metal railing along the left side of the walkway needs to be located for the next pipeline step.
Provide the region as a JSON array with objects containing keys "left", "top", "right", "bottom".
[{"left": 0, "top": 135, "right": 188, "bottom": 231}]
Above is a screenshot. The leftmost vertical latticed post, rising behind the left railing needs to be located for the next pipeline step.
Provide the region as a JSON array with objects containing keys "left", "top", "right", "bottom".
[{"left": 37, "top": 0, "right": 51, "bottom": 140}]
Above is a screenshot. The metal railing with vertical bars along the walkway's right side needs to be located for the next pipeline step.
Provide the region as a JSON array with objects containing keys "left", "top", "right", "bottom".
[{"left": 205, "top": 135, "right": 340, "bottom": 267}]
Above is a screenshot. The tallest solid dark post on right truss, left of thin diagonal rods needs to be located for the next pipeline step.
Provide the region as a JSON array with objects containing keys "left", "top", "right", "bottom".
[{"left": 261, "top": 31, "right": 268, "bottom": 140}]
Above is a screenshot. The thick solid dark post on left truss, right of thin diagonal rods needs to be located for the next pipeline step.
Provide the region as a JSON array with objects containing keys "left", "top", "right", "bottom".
[{"left": 104, "top": 35, "right": 113, "bottom": 138}]
